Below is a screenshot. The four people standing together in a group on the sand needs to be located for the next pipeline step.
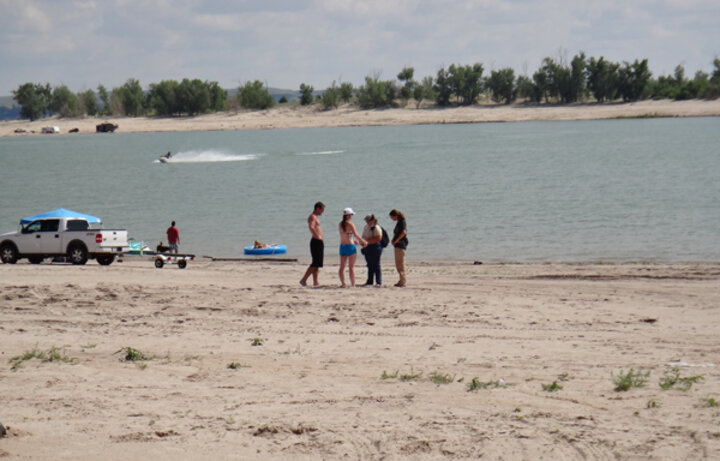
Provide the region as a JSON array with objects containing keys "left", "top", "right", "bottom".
[{"left": 300, "top": 202, "right": 408, "bottom": 287}]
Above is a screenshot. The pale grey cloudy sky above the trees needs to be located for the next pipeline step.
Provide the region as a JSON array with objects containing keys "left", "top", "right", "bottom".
[{"left": 0, "top": 0, "right": 720, "bottom": 95}]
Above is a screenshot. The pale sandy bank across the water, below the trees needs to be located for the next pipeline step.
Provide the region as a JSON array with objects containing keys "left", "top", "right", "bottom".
[{"left": 0, "top": 99, "right": 720, "bottom": 137}]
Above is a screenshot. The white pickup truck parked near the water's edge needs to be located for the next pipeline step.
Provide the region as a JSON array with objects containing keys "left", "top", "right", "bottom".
[{"left": 0, "top": 218, "right": 128, "bottom": 266}]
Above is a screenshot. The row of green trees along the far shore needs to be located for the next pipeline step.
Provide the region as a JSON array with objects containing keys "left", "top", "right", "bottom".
[{"left": 13, "top": 52, "right": 720, "bottom": 120}]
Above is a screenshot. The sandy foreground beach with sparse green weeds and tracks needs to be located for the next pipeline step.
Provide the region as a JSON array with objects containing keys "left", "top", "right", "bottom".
[{"left": 0, "top": 257, "right": 720, "bottom": 460}]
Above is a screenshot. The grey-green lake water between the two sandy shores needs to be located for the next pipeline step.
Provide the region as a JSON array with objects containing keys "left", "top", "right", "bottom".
[{"left": 0, "top": 118, "right": 720, "bottom": 261}]
